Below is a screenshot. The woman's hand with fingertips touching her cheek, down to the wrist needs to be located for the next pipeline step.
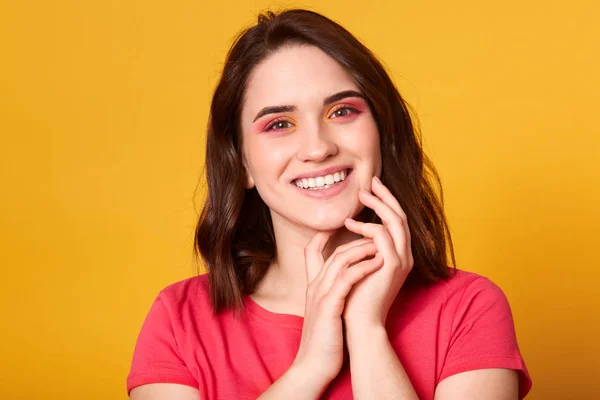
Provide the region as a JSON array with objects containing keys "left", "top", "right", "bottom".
[{"left": 343, "top": 177, "right": 414, "bottom": 329}]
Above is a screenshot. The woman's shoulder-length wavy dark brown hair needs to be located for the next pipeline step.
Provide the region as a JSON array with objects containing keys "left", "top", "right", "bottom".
[{"left": 194, "top": 9, "right": 456, "bottom": 314}]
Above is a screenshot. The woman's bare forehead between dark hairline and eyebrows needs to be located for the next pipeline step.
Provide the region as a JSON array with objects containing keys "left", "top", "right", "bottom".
[{"left": 242, "top": 45, "right": 359, "bottom": 119}]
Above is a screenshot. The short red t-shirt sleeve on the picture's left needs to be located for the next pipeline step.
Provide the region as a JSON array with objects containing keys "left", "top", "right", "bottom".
[{"left": 127, "top": 292, "right": 198, "bottom": 394}]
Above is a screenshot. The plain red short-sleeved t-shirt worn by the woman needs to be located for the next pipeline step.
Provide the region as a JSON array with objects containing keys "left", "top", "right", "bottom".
[{"left": 127, "top": 270, "right": 531, "bottom": 400}]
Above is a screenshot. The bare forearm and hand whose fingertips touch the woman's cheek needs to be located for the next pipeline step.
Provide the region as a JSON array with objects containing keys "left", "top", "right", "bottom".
[{"left": 344, "top": 177, "right": 419, "bottom": 400}]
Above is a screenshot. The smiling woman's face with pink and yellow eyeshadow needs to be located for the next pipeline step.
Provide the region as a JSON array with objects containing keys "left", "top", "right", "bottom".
[{"left": 241, "top": 45, "right": 381, "bottom": 230}]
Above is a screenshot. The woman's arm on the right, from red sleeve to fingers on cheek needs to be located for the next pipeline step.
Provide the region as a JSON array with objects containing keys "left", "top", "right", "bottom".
[{"left": 344, "top": 178, "right": 531, "bottom": 400}]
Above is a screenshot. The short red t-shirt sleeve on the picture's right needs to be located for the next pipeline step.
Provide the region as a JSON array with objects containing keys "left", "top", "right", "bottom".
[{"left": 438, "top": 276, "right": 532, "bottom": 399}]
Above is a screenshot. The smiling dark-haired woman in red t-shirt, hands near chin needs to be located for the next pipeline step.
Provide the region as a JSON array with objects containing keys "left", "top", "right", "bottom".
[{"left": 127, "top": 10, "right": 531, "bottom": 400}]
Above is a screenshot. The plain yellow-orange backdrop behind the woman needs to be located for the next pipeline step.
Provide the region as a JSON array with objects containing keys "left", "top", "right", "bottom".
[{"left": 0, "top": 0, "right": 600, "bottom": 400}]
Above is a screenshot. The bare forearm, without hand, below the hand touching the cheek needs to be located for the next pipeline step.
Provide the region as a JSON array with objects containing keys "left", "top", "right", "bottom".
[{"left": 346, "top": 326, "right": 419, "bottom": 400}]
